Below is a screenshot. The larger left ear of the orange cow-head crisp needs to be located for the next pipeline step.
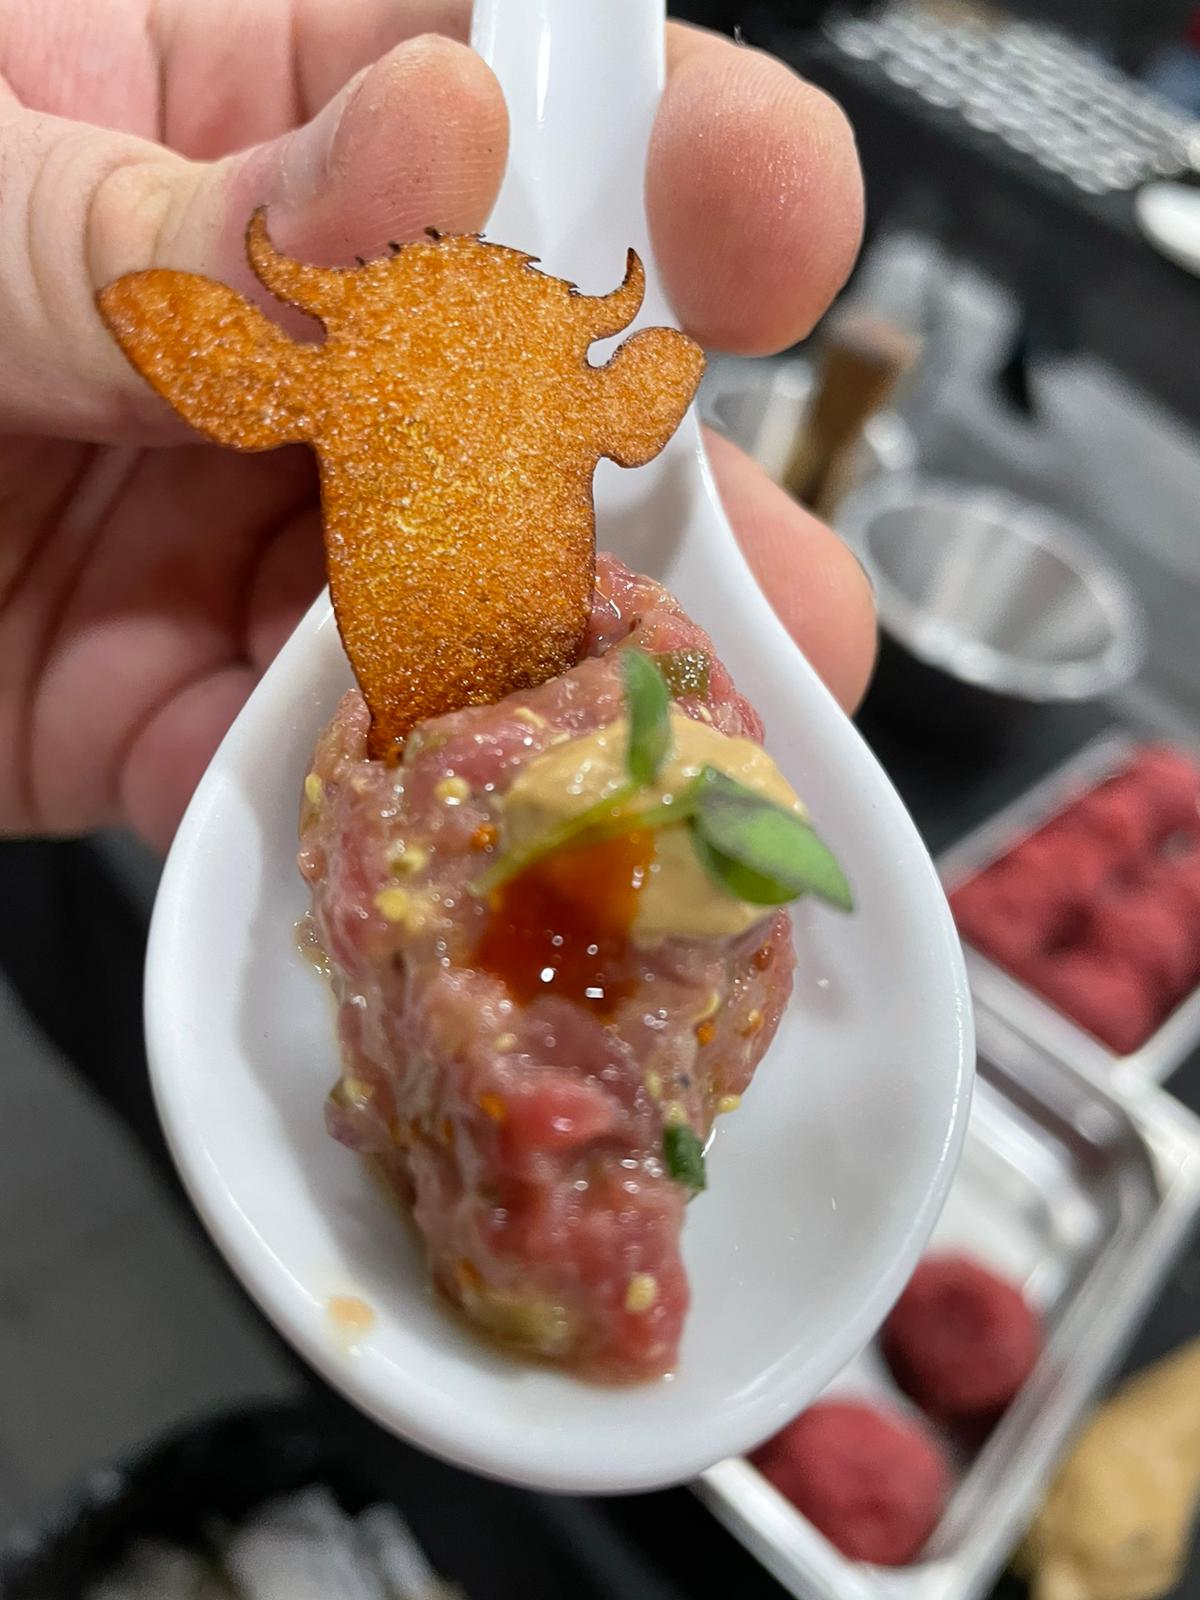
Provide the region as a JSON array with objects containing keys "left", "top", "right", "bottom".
[{"left": 96, "top": 269, "right": 322, "bottom": 450}]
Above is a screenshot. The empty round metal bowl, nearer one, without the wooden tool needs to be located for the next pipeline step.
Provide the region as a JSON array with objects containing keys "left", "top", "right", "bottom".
[{"left": 838, "top": 474, "right": 1144, "bottom": 720}]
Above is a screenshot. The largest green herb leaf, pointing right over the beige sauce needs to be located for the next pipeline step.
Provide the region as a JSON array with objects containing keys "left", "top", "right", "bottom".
[{"left": 688, "top": 766, "right": 854, "bottom": 910}]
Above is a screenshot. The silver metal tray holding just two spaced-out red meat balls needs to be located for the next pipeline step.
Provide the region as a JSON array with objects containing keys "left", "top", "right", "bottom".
[{"left": 696, "top": 1010, "right": 1200, "bottom": 1600}]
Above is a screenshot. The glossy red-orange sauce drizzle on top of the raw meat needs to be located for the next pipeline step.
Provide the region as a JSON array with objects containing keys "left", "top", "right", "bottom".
[{"left": 475, "top": 830, "right": 654, "bottom": 1014}]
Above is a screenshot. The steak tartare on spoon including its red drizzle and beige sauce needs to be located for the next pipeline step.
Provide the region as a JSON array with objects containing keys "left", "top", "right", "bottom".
[{"left": 299, "top": 557, "right": 794, "bottom": 1379}]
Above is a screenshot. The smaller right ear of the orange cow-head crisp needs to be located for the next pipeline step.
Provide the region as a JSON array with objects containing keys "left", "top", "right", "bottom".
[{"left": 594, "top": 328, "right": 704, "bottom": 467}]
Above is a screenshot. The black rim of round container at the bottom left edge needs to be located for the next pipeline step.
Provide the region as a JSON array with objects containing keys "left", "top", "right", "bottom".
[{"left": 0, "top": 1395, "right": 682, "bottom": 1600}]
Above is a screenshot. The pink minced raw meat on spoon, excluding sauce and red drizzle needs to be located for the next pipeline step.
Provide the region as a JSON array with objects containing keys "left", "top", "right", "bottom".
[{"left": 299, "top": 557, "right": 792, "bottom": 1379}]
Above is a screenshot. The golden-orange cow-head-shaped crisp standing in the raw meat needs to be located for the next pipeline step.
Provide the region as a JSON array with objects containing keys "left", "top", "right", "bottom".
[{"left": 99, "top": 211, "right": 704, "bottom": 757}]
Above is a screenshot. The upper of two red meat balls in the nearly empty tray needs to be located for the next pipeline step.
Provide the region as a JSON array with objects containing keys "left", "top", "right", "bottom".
[{"left": 882, "top": 1256, "right": 1042, "bottom": 1422}]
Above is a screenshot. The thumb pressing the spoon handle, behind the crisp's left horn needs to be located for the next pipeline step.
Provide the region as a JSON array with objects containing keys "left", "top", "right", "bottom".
[{"left": 0, "top": 35, "right": 507, "bottom": 443}]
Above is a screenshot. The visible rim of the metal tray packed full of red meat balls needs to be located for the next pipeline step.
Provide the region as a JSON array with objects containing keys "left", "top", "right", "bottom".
[{"left": 938, "top": 733, "right": 1200, "bottom": 1083}]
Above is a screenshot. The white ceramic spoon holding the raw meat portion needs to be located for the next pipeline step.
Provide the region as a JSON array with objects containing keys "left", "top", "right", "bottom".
[{"left": 147, "top": 0, "right": 973, "bottom": 1490}]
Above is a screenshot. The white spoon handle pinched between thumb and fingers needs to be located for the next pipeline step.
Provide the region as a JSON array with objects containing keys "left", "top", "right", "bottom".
[{"left": 470, "top": 0, "right": 678, "bottom": 322}]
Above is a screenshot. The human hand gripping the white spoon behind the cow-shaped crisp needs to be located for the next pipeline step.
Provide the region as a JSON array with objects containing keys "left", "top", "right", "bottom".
[{"left": 0, "top": 0, "right": 874, "bottom": 846}]
